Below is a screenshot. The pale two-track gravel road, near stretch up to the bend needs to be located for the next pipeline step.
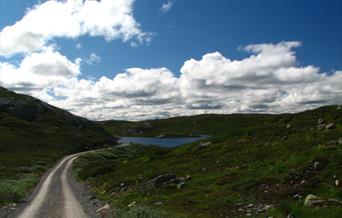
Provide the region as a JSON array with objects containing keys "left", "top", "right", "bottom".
[{"left": 0, "top": 154, "right": 104, "bottom": 218}]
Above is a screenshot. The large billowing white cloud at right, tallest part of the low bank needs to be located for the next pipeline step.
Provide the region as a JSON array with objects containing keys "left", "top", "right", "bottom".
[{"left": 180, "top": 42, "right": 342, "bottom": 113}]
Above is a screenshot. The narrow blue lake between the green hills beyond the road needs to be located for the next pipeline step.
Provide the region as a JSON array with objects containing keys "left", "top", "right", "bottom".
[{"left": 119, "top": 135, "right": 208, "bottom": 148}]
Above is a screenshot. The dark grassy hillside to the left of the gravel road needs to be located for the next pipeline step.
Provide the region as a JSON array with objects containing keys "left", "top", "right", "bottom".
[{"left": 0, "top": 87, "right": 115, "bottom": 204}]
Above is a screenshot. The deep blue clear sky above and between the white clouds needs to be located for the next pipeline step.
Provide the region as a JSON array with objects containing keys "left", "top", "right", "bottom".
[{"left": 0, "top": 0, "right": 342, "bottom": 77}]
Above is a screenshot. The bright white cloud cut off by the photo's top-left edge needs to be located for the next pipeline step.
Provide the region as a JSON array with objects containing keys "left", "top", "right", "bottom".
[{"left": 0, "top": 0, "right": 151, "bottom": 57}]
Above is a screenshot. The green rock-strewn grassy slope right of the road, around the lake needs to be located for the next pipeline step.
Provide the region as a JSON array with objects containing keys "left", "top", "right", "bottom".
[{"left": 75, "top": 106, "right": 342, "bottom": 217}]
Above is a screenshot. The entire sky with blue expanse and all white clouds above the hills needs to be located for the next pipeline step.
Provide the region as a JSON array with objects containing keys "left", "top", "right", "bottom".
[{"left": 0, "top": 0, "right": 342, "bottom": 120}]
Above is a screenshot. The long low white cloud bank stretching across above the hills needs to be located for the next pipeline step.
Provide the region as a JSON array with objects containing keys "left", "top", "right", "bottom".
[{"left": 0, "top": 42, "right": 342, "bottom": 120}]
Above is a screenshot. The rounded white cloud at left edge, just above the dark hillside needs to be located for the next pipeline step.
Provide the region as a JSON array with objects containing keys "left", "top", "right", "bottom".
[{"left": 0, "top": 50, "right": 81, "bottom": 100}]
